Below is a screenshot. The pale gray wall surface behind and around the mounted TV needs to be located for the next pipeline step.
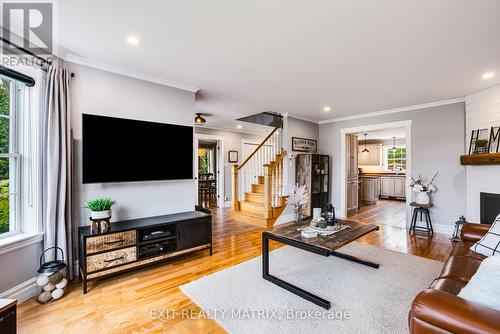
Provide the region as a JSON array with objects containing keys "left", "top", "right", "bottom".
[{"left": 68, "top": 64, "right": 196, "bottom": 226}]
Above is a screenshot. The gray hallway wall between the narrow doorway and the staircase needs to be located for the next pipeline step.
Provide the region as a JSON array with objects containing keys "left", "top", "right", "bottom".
[{"left": 195, "top": 127, "right": 264, "bottom": 201}]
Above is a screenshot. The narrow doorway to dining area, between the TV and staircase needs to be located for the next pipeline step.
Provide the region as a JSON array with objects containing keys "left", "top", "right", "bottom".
[{"left": 195, "top": 134, "right": 224, "bottom": 208}]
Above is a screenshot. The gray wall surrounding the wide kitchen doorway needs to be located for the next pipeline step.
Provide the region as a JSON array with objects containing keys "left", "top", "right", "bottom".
[{"left": 319, "top": 103, "right": 465, "bottom": 231}]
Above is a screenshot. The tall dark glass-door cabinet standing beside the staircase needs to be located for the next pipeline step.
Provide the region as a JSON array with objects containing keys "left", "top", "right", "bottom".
[{"left": 295, "top": 154, "right": 330, "bottom": 217}]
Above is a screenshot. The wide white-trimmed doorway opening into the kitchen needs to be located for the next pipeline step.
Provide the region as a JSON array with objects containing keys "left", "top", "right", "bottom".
[{"left": 339, "top": 121, "right": 411, "bottom": 228}]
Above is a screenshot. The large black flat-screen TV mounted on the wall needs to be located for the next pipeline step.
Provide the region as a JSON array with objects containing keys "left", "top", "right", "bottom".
[{"left": 82, "top": 114, "right": 193, "bottom": 183}]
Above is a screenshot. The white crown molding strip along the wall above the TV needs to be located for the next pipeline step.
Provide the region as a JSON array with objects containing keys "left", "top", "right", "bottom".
[{"left": 62, "top": 54, "right": 200, "bottom": 93}]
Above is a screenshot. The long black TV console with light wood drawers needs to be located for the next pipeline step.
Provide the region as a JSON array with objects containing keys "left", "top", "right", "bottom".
[{"left": 78, "top": 211, "right": 212, "bottom": 293}]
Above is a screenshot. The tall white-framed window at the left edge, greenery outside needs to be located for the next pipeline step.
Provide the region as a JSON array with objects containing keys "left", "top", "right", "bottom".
[{"left": 0, "top": 77, "right": 21, "bottom": 236}]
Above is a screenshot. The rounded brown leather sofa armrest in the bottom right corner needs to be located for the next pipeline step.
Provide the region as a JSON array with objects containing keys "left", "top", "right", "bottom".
[{"left": 409, "top": 289, "right": 500, "bottom": 334}]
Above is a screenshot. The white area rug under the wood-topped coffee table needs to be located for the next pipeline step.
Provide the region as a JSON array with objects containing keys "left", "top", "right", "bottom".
[{"left": 181, "top": 243, "right": 443, "bottom": 334}]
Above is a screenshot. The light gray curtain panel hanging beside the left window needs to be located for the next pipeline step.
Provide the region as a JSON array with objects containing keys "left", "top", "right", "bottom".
[{"left": 43, "top": 62, "right": 74, "bottom": 279}]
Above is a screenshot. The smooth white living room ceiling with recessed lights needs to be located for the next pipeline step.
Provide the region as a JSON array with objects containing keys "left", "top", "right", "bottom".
[{"left": 56, "top": 0, "right": 500, "bottom": 128}]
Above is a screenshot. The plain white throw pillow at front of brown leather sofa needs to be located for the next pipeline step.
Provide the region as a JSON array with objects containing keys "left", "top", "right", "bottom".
[{"left": 458, "top": 256, "right": 500, "bottom": 311}]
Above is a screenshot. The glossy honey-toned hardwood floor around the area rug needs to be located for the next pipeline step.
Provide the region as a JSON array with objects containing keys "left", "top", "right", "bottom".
[{"left": 18, "top": 202, "right": 451, "bottom": 334}]
